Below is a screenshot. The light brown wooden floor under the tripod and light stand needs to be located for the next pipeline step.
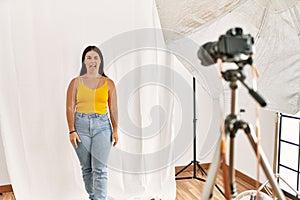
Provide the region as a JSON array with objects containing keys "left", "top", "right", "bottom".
[{"left": 0, "top": 167, "right": 289, "bottom": 200}]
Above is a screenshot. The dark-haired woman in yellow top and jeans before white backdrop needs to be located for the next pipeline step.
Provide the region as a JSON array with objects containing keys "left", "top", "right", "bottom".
[{"left": 66, "top": 46, "right": 118, "bottom": 200}]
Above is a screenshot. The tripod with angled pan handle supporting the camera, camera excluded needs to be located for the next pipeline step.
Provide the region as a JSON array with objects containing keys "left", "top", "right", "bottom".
[{"left": 201, "top": 63, "right": 285, "bottom": 200}]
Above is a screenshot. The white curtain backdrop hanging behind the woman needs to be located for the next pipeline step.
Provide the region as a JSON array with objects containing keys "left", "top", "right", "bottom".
[{"left": 0, "top": 0, "right": 178, "bottom": 200}]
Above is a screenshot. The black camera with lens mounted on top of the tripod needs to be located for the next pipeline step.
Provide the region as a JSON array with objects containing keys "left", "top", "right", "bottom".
[{"left": 198, "top": 27, "right": 254, "bottom": 66}]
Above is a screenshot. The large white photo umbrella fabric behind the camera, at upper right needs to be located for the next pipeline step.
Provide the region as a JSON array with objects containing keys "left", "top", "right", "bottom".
[{"left": 156, "top": 0, "right": 300, "bottom": 114}]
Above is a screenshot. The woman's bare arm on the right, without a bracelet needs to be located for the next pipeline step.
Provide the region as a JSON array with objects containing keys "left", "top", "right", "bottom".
[{"left": 107, "top": 79, "right": 119, "bottom": 146}]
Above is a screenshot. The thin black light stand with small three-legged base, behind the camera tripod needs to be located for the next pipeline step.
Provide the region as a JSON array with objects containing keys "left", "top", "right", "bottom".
[{"left": 175, "top": 77, "right": 224, "bottom": 195}]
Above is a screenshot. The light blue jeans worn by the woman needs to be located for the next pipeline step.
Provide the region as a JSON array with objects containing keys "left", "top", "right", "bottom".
[{"left": 75, "top": 112, "right": 112, "bottom": 200}]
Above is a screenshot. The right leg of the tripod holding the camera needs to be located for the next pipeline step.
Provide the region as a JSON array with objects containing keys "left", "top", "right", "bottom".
[{"left": 247, "top": 131, "right": 285, "bottom": 199}]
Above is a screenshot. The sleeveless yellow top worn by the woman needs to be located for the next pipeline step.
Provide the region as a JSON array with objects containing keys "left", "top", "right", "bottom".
[{"left": 76, "top": 77, "right": 108, "bottom": 114}]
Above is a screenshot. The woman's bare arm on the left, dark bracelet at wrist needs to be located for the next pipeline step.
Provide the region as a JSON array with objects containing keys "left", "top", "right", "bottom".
[{"left": 66, "top": 78, "right": 80, "bottom": 148}]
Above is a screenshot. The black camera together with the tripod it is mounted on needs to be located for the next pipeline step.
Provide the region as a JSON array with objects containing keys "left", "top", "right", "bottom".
[{"left": 198, "top": 28, "right": 285, "bottom": 200}]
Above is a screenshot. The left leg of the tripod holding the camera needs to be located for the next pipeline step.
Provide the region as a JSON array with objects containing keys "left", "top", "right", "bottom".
[{"left": 201, "top": 140, "right": 221, "bottom": 200}]
